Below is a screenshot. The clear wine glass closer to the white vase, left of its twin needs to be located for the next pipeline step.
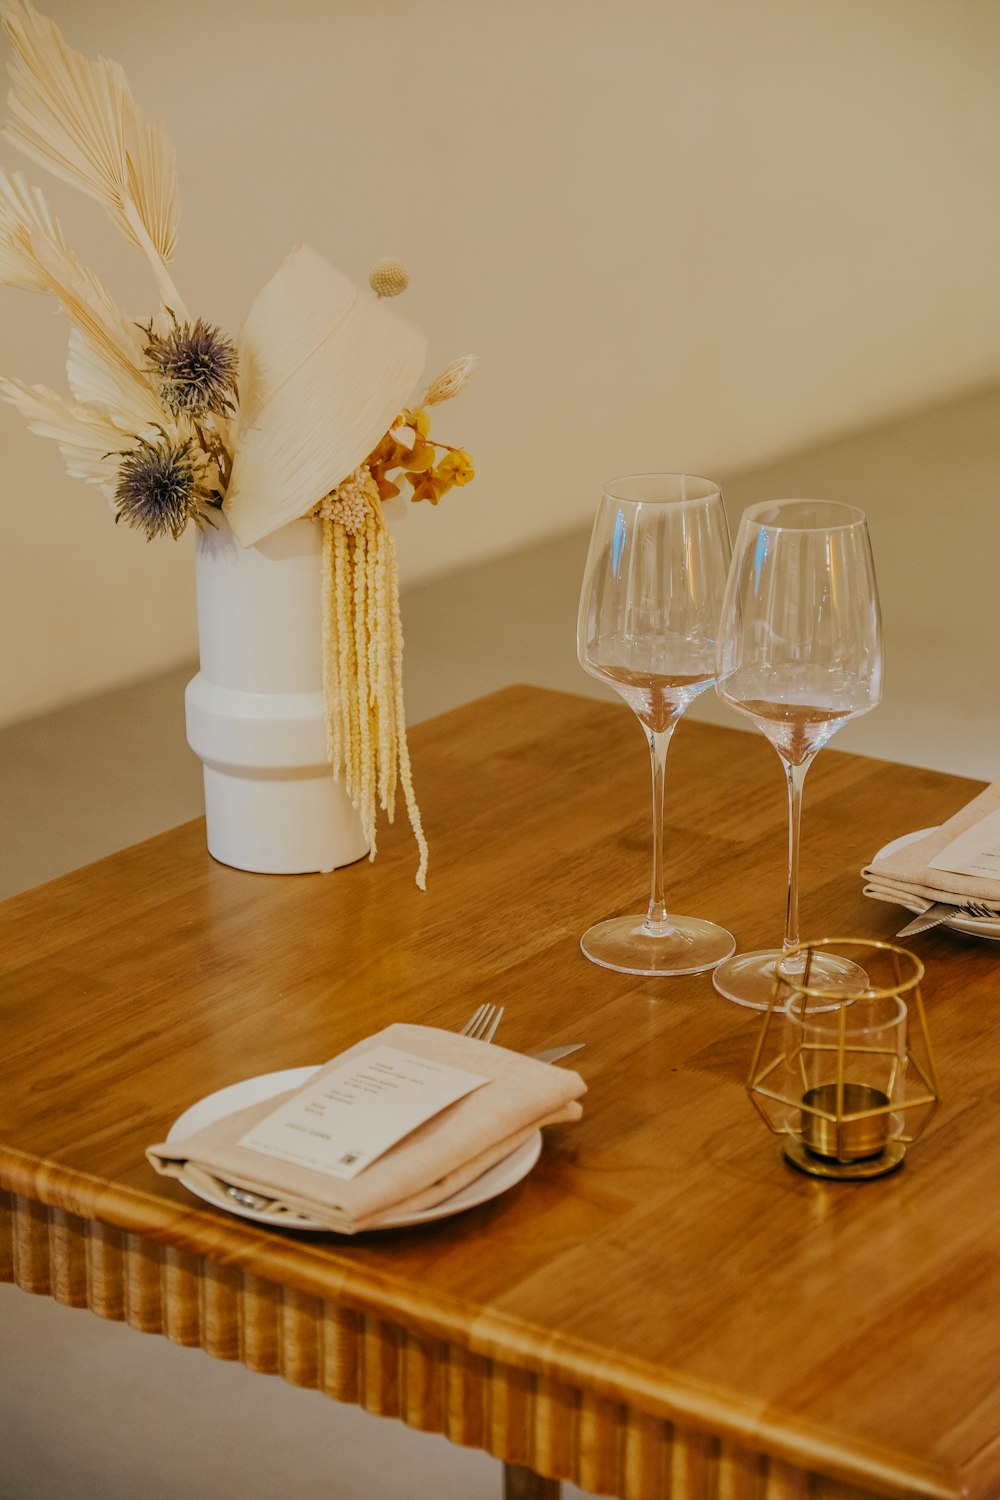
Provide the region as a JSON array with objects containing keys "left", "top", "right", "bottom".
[{"left": 577, "top": 474, "right": 736, "bottom": 974}]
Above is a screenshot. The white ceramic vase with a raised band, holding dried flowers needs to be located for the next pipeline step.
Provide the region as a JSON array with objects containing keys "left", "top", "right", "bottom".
[{"left": 184, "top": 513, "right": 369, "bottom": 875}]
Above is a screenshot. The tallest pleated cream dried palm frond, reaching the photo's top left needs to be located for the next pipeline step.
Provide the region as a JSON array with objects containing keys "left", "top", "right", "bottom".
[{"left": 0, "top": 0, "right": 183, "bottom": 314}]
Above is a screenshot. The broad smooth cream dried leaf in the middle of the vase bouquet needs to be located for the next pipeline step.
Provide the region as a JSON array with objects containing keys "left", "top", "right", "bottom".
[{"left": 225, "top": 246, "right": 427, "bottom": 546}]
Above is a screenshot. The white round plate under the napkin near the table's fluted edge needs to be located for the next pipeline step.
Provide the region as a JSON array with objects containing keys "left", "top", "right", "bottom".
[{"left": 166, "top": 1065, "right": 541, "bottom": 1235}]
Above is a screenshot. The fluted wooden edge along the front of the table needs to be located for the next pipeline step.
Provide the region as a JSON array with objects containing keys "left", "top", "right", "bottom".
[{"left": 0, "top": 1151, "right": 966, "bottom": 1500}]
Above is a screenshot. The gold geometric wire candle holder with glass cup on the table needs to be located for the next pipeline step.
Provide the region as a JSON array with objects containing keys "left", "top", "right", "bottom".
[{"left": 747, "top": 938, "right": 939, "bottom": 1179}]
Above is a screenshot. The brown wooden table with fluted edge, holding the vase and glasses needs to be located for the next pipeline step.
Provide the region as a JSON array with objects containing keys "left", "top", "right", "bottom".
[{"left": 0, "top": 689, "right": 1000, "bottom": 1500}]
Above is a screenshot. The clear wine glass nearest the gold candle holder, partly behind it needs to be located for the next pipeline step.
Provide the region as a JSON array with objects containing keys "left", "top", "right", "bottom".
[{"left": 712, "top": 500, "right": 882, "bottom": 1010}]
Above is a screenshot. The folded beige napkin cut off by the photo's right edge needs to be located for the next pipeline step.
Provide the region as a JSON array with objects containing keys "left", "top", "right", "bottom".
[{"left": 861, "top": 782, "right": 1000, "bottom": 914}]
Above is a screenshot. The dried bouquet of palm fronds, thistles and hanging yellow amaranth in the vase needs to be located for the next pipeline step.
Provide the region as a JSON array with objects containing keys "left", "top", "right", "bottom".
[{"left": 0, "top": 0, "right": 475, "bottom": 888}]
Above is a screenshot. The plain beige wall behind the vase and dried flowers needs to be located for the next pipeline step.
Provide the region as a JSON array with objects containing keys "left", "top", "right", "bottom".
[{"left": 0, "top": 0, "right": 1000, "bottom": 722}]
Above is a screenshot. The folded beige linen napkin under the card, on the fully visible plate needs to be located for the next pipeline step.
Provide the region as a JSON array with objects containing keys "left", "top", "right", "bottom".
[{"left": 147, "top": 1023, "right": 586, "bottom": 1235}]
